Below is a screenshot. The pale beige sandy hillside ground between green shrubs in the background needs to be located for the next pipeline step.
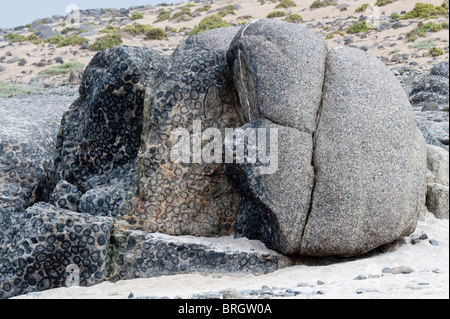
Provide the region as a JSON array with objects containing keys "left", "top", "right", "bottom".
[{"left": 0, "top": 0, "right": 449, "bottom": 84}]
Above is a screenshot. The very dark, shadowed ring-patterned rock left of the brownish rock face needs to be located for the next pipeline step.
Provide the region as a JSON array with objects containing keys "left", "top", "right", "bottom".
[{"left": 52, "top": 46, "right": 167, "bottom": 225}]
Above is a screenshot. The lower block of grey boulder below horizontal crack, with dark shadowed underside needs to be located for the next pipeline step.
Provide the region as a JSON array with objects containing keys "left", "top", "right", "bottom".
[{"left": 227, "top": 119, "right": 314, "bottom": 255}]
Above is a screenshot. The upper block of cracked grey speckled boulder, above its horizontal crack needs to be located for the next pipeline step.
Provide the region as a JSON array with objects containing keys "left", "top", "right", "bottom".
[{"left": 227, "top": 19, "right": 327, "bottom": 134}]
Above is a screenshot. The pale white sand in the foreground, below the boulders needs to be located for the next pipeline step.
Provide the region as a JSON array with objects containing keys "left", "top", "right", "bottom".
[{"left": 12, "top": 213, "right": 449, "bottom": 299}]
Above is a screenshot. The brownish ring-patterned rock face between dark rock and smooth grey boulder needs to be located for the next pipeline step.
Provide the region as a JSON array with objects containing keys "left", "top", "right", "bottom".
[{"left": 134, "top": 39, "right": 243, "bottom": 236}]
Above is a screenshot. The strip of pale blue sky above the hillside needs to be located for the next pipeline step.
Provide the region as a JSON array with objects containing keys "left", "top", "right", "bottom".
[{"left": 0, "top": 0, "right": 183, "bottom": 28}]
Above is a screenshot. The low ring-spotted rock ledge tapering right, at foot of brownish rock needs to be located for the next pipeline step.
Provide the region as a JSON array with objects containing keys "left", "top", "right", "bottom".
[{"left": 110, "top": 227, "right": 289, "bottom": 281}]
